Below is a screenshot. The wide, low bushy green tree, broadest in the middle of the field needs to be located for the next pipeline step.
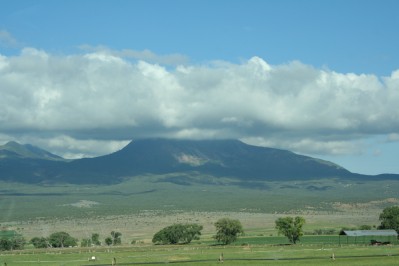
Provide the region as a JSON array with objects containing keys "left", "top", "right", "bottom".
[{"left": 152, "top": 224, "right": 203, "bottom": 245}]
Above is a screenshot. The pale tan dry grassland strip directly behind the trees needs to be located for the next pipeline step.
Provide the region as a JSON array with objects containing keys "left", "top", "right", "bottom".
[{"left": 2, "top": 210, "right": 379, "bottom": 244}]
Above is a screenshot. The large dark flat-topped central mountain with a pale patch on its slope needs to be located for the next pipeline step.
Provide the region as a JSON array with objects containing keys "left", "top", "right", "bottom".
[{"left": 62, "top": 139, "right": 351, "bottom": 183}]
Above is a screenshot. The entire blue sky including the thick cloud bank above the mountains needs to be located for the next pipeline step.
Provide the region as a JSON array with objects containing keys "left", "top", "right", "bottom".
[{"left": 0, "top": 0, "right": 399, "bottom": 175}]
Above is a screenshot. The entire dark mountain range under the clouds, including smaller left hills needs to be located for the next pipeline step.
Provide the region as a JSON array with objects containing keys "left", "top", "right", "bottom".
[{"left": 0, "top": 139, "right": 399, "bottom": 184}]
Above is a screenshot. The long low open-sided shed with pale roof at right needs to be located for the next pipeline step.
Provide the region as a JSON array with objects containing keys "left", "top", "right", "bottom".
[{"left": 339, "top": 230, "right": 398, "bottom": 245}]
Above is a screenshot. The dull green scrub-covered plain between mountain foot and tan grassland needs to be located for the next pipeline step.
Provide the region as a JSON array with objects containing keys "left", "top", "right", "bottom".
[{"left": 0, "top": 174, "right": 399, "bottom": 223}]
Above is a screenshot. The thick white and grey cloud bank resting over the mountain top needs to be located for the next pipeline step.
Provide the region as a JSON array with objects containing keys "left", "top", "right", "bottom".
[{"left": 0, "top": 48, "right": 399, "bottom": 157}]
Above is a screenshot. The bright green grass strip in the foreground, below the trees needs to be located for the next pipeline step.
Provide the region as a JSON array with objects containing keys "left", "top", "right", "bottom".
[{"left": 0, "top": 237, "right": 399, "bottom": 266}]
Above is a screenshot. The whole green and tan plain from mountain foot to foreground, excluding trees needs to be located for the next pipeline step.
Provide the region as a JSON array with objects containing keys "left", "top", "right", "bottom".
[{"left": 0, "top": 174, "right": 399, "bottom": 265}]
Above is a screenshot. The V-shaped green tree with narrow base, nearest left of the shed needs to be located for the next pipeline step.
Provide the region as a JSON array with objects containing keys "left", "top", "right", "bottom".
[{"left": 276, "top": 216, "right": 305, "bottom": 244}]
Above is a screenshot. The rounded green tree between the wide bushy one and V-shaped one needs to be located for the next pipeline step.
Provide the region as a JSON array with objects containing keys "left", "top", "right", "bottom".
[{"left": 214, "top": 218, "right": 244, "bottom": 245}]
